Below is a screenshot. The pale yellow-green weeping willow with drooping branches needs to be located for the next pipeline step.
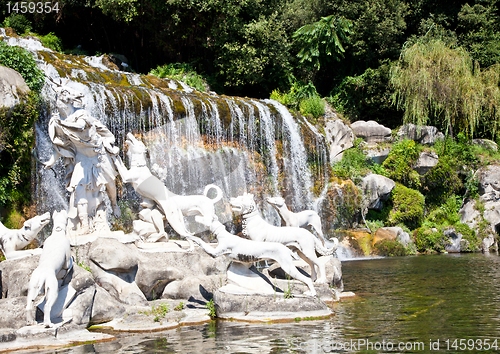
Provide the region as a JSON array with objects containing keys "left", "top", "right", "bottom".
[{"left": 390, "top": 39, "right": 500, "bottom": 137}]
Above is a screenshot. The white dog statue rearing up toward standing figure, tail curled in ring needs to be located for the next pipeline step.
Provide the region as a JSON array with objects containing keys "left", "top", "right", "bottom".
[{"left": 115, "top": 133, "right": 222, "bottom": 249}]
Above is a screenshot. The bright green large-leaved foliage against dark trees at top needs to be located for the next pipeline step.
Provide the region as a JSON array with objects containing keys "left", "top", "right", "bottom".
[{"left": 292, "top": 15, "right": 352, "bottom": 70}]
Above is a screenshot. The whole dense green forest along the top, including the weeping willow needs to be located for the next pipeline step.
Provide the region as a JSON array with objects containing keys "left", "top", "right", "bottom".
[{"left": 0, "top": 0, "right": 500, "bottom": 137}]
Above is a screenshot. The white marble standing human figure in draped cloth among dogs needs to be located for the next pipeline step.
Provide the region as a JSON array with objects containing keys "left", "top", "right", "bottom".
[{"left": 45, "top": 85, "right": 121, "bottom": 234}]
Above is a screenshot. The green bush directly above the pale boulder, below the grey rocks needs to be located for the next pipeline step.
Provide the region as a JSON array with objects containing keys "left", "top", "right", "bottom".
[{"left": 382, "top": 139, "right": 420, "bottom": 188}]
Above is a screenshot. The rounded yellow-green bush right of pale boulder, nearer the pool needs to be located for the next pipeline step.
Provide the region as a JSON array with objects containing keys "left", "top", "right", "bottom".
[{"left": 388, "top": 183, "right": 424, "bottom": 230}]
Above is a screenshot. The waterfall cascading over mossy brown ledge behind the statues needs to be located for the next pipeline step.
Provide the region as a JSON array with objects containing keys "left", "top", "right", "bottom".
[{"left": 4, "top": 30, "right": 338, "bottom": 234}]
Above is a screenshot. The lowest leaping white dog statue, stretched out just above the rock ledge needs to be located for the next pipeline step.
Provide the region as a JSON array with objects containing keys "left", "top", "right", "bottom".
[{"left": 189, "top": 216, "right": 316, "bottom": 296}]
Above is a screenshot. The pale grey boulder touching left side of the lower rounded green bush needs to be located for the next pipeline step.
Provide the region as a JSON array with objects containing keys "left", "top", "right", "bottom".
[{"left": 361, "top": 173, "right": 396, "bottom": 210}]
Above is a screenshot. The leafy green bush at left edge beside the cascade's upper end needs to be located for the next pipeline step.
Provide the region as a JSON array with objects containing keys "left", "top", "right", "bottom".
[{"left": 0, "top": 42, "right": 45, "bottom": 92}]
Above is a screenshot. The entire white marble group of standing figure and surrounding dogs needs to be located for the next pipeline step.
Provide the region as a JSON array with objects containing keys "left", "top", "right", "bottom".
[{"left": 0, "top": 85, "right": 338, "bottom": 327}]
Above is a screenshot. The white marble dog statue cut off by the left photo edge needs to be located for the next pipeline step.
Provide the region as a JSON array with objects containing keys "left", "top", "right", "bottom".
[{"left": 0, "top": 212, "right": 50, "bottom": 259}]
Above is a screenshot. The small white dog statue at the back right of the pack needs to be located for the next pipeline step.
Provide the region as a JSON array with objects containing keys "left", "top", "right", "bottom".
[{"left": 267, "top": 197, "right": 325, "bottom": 246}]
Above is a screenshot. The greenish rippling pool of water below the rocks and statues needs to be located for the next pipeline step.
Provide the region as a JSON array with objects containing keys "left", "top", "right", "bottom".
[{"left": 46, "top": 254, "right": 500, "bottom": 353}]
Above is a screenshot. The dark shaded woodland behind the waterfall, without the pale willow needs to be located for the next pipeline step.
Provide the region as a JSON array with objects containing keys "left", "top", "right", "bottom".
[{"left": 0, "top": 0, "right": 500, "bottom": 137}]
